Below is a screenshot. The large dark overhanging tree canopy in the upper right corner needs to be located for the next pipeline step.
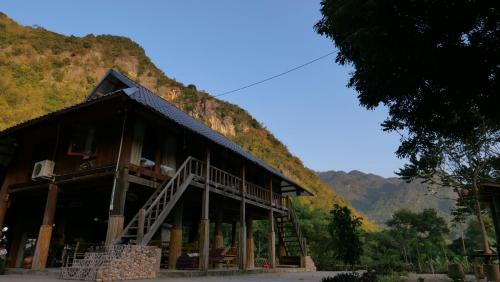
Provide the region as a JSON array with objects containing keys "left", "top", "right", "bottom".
[{"left": 315, "top": 0, "right": 500, "bottom": 140}]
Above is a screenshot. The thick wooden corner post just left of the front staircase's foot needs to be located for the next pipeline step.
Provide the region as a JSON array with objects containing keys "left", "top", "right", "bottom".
[{"left": 105, "top": 168, "right": 130, "bottom": 245}]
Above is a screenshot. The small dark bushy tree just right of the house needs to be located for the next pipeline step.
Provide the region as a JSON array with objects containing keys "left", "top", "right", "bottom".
[{"left": 328, "top": 204, "right": 363, "bottom": 265}]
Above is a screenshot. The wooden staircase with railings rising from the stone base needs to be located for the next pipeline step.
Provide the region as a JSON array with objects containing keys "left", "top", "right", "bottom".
[{"left": 113, "top": 157, "right": 204, "bottom": 246}]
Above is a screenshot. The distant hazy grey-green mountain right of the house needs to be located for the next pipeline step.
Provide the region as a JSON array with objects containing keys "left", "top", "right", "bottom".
[{"left": 318, "top": 170, "right": 457, "bottom": 225}]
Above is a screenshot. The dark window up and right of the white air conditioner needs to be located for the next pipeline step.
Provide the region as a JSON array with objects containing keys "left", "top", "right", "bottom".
[{"left": 68, "top": 126, "right": 96, "bottom": 156}]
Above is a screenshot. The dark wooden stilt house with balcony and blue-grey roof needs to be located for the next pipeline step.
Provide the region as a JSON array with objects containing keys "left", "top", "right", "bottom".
[{"left": 0, "top": 70, "right": 310, "bottom": 270}]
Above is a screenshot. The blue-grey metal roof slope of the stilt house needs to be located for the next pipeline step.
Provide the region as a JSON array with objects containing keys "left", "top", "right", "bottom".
[{"left": 96, "top": 69, "right": 312, "bottom": 194}]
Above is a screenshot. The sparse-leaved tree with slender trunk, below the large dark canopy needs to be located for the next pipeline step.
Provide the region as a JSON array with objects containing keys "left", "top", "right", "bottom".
[{"left": 399, "top": 128, "right": 500, "bottom": 254}]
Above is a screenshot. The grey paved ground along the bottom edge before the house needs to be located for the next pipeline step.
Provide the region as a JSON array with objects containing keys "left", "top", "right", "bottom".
[{"left": 0, "top": 271, "right": 339, "bottom": 282}]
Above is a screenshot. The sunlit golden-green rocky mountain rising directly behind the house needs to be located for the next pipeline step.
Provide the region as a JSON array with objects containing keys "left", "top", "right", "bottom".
[{"left": 0, "top": 13, "right": 376, "bottom": 230}]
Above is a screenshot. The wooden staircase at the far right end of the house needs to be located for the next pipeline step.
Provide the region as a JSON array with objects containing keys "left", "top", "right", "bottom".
[{"left": 275, "top": 199, "right": 307, "bottom": 257}]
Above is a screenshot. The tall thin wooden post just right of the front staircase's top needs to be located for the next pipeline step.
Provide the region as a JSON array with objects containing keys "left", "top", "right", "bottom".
[{"left": 200, "top": 149, "right": 210, "bottom": 270}]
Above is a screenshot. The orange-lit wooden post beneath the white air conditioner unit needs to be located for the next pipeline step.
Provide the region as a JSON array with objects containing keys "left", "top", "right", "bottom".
[{"left": 31, "top": 183, "right": 59, "bottom": 271}]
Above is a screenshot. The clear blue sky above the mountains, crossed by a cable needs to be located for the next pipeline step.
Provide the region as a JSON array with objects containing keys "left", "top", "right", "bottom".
[{"left": 0, "top": 0, "right": 404, "bottom": 176}]
